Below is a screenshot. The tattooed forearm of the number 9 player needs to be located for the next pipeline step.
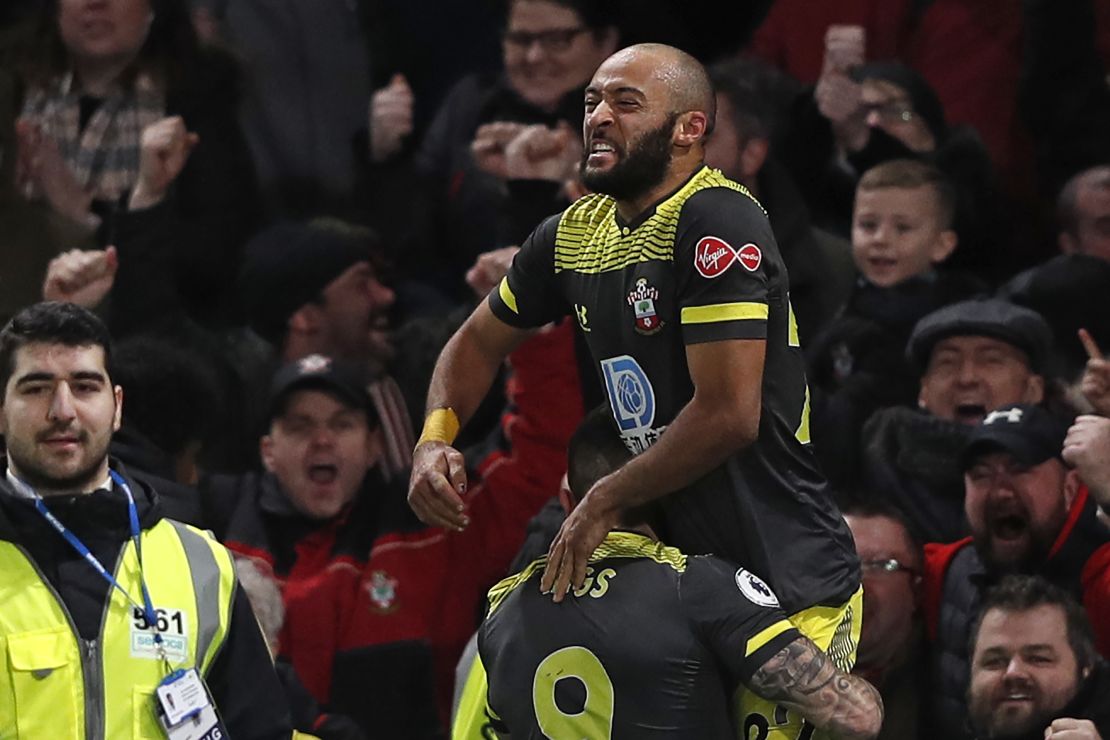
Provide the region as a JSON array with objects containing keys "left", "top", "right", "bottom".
[{"left": 748, "top": 637, "right": 882, "bottom": 740}]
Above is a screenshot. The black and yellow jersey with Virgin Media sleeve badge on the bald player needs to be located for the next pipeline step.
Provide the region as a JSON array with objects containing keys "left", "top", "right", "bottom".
[{"left": 490, "top": 168, "right": 859, "bottom": 614}]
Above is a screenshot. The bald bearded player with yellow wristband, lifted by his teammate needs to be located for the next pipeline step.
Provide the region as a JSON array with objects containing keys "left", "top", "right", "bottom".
[{"left": 408, "top": 44, "right": 860, "bottom": 737}]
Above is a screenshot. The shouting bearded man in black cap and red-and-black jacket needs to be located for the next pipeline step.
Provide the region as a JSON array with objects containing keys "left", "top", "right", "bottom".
[{"left": 925, "top": 404, "right": 1110, "bottom": 738}]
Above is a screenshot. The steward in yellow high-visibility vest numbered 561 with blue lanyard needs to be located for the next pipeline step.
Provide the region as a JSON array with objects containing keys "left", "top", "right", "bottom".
[{"left": 0, "top": 303, "right": 292, "bottom": 740}]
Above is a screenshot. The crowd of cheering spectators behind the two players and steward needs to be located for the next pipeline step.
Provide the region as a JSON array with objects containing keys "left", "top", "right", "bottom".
[{"left": 0, "top": 0, "right": 1110, "bottom": 740}]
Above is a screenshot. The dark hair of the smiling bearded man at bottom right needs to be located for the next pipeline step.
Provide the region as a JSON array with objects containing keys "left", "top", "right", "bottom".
[{"left": 968, "top": 576, "right": 1099, "bottom": 675}]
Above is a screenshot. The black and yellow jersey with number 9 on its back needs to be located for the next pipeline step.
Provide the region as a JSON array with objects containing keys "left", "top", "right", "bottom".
[{"left": 478, "top": 531, "right": 798, "bottom": 740}]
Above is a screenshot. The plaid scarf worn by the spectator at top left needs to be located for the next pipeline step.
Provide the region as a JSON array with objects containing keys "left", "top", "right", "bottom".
[{"left": 22, "top": 73, "right": 165, "bottom": 201}]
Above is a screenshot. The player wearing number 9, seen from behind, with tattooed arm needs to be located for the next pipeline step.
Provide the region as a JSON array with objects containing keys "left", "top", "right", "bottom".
[{"left": 478, "top": 408, "right": 882, "bottom": 740}]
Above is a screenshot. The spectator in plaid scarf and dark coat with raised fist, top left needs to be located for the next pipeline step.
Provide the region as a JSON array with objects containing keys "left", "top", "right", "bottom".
[{"left": 4, "top": 0, "right": 255, "bottom": 333}]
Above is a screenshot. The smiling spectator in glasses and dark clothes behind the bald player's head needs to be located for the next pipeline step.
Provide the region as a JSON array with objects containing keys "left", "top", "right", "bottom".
[{"left": 406, "top": 0, "right": 617, "bottom": 301}]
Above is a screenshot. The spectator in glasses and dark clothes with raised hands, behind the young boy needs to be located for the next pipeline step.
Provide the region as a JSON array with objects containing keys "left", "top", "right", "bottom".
[{"left": 803, "top": 54, "right": 1012, "bottom": 278}]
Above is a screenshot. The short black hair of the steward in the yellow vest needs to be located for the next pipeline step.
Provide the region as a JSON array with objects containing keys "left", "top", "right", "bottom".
[{"left": 0, "top": 301, "right": 112, "bottom": 396}]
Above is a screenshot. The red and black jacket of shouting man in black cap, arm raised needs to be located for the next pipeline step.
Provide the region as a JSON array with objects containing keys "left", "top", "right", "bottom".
[{"left": 205, "top": 322, "right": 583, "bottom": 738}]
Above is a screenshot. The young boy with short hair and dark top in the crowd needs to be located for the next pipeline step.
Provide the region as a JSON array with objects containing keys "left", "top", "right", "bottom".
[{"left": 808, "top": 160, "right": 985, "bottom": 489}]
